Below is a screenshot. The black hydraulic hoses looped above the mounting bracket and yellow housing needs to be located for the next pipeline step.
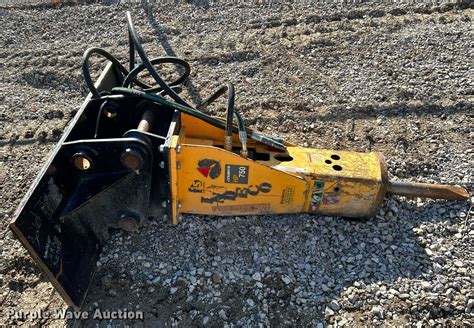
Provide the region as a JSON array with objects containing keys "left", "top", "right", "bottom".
[{"left": 82, "top": 11, "right": 285, "bottom": 152}]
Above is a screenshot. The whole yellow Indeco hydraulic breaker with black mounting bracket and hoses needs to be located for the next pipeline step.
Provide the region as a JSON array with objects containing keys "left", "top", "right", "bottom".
[{"left": 10, "top": 13, "right": 469, "bottom": 308}]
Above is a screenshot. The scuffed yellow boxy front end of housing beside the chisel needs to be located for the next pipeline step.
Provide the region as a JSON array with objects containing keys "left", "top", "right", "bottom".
[{"left": 282, "top": 147, "right": 387, "bottom": 217}]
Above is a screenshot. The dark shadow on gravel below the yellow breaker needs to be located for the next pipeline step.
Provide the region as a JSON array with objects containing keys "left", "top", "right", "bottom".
[{"left": 65, "top": 196, "right": 464, "bottom": 327}]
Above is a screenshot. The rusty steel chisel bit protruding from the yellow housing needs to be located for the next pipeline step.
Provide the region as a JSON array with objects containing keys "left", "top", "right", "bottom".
[{"left": 387, "top": 181, "right": 469, "bottom": 200}]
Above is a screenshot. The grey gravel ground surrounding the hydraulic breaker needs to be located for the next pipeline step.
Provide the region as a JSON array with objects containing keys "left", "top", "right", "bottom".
[{"left": 0, "top": 1, "right": 474, "bottom": 328}]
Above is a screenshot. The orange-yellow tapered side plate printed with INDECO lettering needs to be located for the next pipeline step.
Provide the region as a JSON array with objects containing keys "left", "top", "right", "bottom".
[{"left": 178, "top": 144, "right": 308, "bottom": 215}]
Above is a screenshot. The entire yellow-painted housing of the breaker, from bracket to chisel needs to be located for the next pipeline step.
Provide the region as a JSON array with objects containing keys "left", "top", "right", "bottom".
[{"left": 170, "top": 115, "right": 387, "bottom": 223}]
